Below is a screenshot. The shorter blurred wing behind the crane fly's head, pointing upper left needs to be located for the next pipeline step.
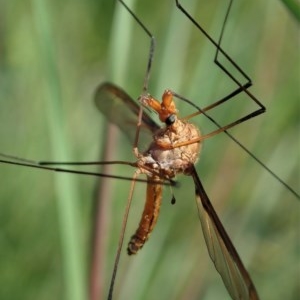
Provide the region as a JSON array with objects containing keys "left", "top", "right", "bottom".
[{"left": 95, "top": 82, "right": 160, "bottom": 145}]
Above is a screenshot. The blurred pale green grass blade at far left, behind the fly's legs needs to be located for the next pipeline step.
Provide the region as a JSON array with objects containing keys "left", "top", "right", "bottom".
[{"left": 33, "top": 0, "right": 86, "bottom": 300}]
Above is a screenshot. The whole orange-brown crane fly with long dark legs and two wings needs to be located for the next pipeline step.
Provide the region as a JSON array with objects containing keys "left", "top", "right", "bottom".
[{"left": 1, "top": 1, "right": 299, "bottom": 299}]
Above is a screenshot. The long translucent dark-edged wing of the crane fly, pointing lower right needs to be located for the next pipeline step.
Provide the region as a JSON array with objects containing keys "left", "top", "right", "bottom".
[{"left": 192, "top": 168, "right": 259, "bottom": 300}]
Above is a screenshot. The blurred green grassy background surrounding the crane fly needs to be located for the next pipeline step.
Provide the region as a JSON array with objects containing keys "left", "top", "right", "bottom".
[{"left": 0, "top": 0, "right": 300, "bottom": 300}]
